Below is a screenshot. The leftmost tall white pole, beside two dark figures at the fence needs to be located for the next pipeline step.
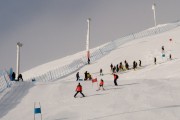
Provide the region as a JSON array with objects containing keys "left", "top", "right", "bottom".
[{"left": 16, "top": 42, "right": 22, "bottom": 79}]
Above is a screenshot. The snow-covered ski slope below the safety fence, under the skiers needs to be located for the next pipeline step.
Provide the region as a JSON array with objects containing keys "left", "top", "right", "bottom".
[{"left": 0, "top": 27, "right": 180, "bottom": 120}]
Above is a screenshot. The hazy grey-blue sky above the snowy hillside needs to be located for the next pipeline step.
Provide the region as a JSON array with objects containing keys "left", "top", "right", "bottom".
[{"left": 0, "top": 0, "right": 180, "bottom": 72}]
